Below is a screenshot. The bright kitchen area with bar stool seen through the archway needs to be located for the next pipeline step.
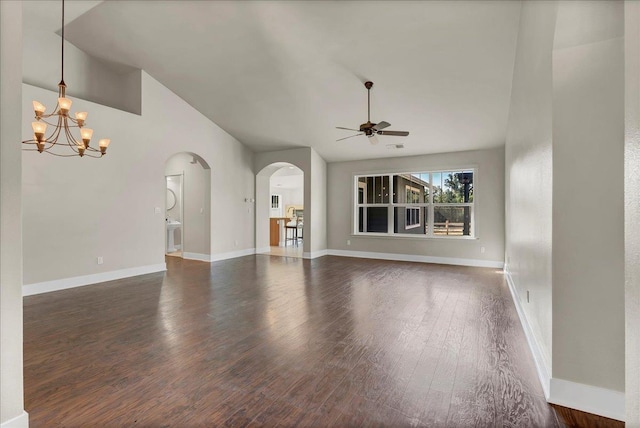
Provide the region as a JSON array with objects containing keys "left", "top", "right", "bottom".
[{"left": 269, "top": 164, "right": 304, "bottom": 258}]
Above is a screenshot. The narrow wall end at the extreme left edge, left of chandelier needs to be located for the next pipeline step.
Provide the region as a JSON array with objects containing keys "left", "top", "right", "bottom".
[{"left": 0, "top": 1, "right": 29, "bottom": 427}]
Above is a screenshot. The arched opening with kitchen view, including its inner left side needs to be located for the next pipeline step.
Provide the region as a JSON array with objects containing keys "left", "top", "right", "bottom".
[{"left": 256, "top": 162, "right": 305, "bottom": 258}]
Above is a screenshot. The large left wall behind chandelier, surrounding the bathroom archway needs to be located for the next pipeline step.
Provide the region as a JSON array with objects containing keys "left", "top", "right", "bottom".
[{"left": 22, "top": 73, "right": 254, "bottom": 284}]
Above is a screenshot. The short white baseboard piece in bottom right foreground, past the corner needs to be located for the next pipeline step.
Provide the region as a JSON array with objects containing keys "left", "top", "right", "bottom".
[{"left": 547, "top": 378, "right": 625, "bottom": 422}]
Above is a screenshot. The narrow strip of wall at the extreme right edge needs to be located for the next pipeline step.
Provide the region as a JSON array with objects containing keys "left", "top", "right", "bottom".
[{"left": 624, "top": 1, "right": 640, "bottom": 422}]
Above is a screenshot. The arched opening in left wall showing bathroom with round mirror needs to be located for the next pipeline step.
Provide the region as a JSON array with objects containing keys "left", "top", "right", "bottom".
[{"left": 164, "top": 152, "right": 211, "bottom": 260}]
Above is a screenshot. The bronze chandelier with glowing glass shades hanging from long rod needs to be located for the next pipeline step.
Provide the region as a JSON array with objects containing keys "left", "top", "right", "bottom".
[{"left": 22, "top": 0, "right": 111, "bottom": 158}]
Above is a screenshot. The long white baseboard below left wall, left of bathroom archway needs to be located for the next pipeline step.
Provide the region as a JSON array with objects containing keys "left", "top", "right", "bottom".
[{"left": 22, "top": 263, "right": 167, "bottom": 296}]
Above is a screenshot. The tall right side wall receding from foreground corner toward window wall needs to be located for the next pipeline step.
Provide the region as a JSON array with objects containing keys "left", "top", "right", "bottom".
[{"left": 505, "top": 1, "right": 558, "bottom": 392}]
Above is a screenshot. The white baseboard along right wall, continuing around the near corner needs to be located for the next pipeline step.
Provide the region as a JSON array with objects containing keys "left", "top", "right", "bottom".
[{"left": 504, "top": 266, "right": 625, "bottom": 421}]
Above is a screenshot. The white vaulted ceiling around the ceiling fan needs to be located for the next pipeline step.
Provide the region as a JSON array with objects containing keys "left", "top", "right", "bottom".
[{"left": 33, "top": 1, "right": 520, "bottom": 161}]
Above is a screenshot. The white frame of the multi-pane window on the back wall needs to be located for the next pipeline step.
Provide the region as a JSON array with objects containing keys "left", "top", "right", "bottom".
[{"left": 351, "top": 166, "right": 478, "bottom": 240}]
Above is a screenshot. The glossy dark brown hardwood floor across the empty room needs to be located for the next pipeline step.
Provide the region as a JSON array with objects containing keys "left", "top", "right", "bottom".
[{"left": 24, "top": 255, "right": 620, "bottom": 427}]
